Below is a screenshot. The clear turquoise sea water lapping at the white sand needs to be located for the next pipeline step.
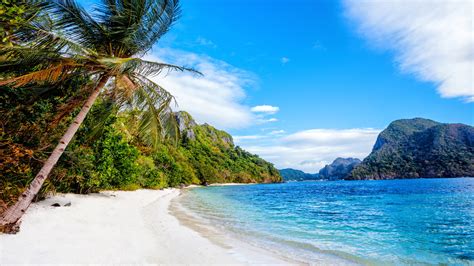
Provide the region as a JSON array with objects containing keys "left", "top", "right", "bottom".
[{"left": 181, "top": 178, "right": 474, "bottom": 265}]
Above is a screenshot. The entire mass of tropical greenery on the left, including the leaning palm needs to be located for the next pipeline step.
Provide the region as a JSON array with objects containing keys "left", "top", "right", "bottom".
[{"left": 0, "top": 0, "right": 280, "bottom": 232}]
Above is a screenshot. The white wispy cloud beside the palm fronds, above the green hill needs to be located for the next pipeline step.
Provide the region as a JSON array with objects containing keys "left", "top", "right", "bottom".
[{"left": 146, "top": 49, "right": 258, "bottom": 129}]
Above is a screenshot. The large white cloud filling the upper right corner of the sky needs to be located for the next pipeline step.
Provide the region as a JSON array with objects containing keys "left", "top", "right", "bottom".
[{"left": 344, "top": 0, "right": 474, "bottom": 101}]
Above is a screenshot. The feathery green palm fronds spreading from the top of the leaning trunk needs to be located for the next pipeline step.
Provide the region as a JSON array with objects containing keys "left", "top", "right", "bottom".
[{"left": 0, "top": 0, "right": 194, "bottom": 154}]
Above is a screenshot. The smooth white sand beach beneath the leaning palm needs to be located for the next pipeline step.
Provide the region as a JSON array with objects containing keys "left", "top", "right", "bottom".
[{"left": 0, "top": 189, "right": 291, "bottom": 265}]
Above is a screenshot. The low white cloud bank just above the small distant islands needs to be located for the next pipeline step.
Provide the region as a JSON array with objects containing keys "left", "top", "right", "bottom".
[{"left": 235, "top": 128, "right": 380, "bottom": 173}]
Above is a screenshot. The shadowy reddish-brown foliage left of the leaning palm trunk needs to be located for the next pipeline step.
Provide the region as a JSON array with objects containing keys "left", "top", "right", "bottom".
[{"left": 0, "top": 76, "right": 89, "bottom": 208}]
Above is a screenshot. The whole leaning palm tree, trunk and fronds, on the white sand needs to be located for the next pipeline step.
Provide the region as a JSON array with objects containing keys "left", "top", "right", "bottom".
[{"left": 0, "top": 0, "right": 193, "bottom": 233}]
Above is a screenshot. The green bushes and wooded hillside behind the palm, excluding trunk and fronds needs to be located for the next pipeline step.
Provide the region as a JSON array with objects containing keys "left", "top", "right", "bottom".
[{"left": 0, "top": 91, "right": 281, "bottom": 209}]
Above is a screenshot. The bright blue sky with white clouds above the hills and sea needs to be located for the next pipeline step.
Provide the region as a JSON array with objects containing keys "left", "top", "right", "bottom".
[{"left": 82, "top": 0, "right": 474, "bottom": 172}]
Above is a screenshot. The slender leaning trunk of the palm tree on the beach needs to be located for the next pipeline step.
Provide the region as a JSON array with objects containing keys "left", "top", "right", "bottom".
[{"left": 0, "top": 75, "right": 109, "bottom": 233}]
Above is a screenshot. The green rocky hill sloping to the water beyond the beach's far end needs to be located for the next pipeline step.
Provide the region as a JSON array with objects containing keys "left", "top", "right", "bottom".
[{"left": 170, "top": 112, "right": 281, "bottom": 183}]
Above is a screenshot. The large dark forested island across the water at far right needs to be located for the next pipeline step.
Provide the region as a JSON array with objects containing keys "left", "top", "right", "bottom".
[{"left": 345, "top": 118, "right": 474, "bottom": 180}]
